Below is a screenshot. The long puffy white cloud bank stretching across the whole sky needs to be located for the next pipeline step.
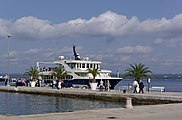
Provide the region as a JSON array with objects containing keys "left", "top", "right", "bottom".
[{"left": 0, "top": 11, "right": 182, "bottom": 39}]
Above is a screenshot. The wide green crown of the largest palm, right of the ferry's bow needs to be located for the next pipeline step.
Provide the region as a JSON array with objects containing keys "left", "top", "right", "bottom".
[{"left": 123, "top": 63, "right": 152, "bottom": 83}]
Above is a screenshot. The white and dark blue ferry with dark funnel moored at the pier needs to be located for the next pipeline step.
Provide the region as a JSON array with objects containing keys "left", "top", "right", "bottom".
[{"left": 36, "top": 45, "right": 122, "bottom": 89}]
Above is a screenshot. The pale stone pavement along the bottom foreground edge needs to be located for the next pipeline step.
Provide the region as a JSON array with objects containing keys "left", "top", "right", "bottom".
[{"left": 0, "top": 104, "right": 182, "bottom": 120}]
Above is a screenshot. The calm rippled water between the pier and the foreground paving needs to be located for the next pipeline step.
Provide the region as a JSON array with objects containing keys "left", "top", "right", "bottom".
[{"left": 0, "top": 92, "right": 124, "bottom": 115}]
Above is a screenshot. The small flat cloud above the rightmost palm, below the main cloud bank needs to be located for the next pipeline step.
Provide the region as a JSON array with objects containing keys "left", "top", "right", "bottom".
[{"left": 117, "top": 45, "right": 152, "bottom": 54}]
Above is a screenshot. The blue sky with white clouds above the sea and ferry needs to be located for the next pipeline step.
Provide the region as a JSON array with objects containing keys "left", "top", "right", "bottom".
[{"left": 0, "top": 0, "right": 182, "bottom": 73}]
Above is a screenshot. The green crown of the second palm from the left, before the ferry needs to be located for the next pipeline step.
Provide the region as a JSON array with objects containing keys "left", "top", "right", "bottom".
[{"left": 52, "top": 66, "right": 67, "bottom": 80}]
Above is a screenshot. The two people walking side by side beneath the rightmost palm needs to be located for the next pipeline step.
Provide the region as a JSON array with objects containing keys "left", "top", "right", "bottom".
[{"left": 133, "top": 80, "right": 144, "bottom": 93}]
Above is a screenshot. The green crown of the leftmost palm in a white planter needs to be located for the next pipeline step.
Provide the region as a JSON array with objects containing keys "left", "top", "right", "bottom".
[{"left": 25, "top": 67, "right": 39, "bottom": 81}]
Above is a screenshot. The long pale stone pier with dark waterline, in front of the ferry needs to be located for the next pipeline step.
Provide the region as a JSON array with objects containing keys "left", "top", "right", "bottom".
[{"left": 0, "top": 86, "right": 182, "bottom": 105}]
